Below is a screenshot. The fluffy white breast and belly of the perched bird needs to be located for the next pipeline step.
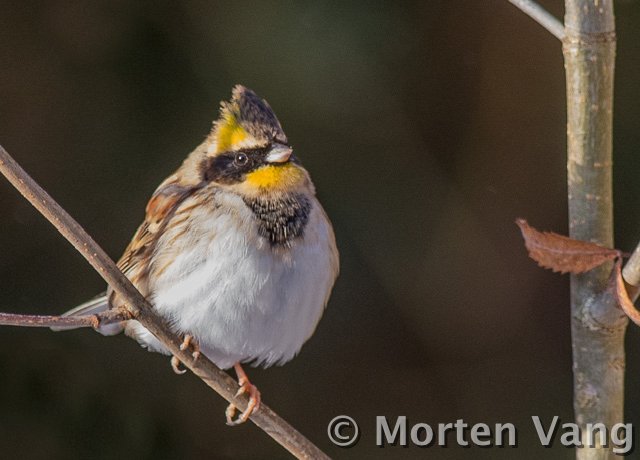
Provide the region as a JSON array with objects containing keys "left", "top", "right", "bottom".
[{"left": 122, "top": 189, "right": 337, "bottom": 368}]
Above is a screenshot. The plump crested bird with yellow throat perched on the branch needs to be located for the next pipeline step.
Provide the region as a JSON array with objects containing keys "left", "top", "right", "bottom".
[{"left": 56, "top": 85, "right": 339, "bottom": 425}]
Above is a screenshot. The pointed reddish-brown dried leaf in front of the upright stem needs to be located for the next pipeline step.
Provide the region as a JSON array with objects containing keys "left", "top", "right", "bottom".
[{"left": 516, "top": 219, "right": 622, "bottom": 273}]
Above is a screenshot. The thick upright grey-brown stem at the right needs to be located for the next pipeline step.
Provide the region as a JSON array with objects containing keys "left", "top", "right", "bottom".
[{"left": 563, "top": 0, "right": 627, "bottom": 460}]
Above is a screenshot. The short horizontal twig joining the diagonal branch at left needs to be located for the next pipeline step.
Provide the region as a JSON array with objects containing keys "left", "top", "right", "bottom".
[{"left": 0, "top": 310, "right": 131, "bottom": 329}]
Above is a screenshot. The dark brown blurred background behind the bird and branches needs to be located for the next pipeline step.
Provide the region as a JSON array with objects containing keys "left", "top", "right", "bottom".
[{"left": 0, "top": 0, "right": 640, "bottom": 459}]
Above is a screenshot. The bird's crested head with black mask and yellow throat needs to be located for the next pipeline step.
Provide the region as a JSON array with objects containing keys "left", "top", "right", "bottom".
[{"left": 201, "top": 85, "right": 313, "bottom": 196}]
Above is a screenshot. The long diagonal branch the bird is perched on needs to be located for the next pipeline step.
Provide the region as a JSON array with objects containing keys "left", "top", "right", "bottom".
[{"left": 0, "top": 146, "right": 329, "bottom": 459}]
